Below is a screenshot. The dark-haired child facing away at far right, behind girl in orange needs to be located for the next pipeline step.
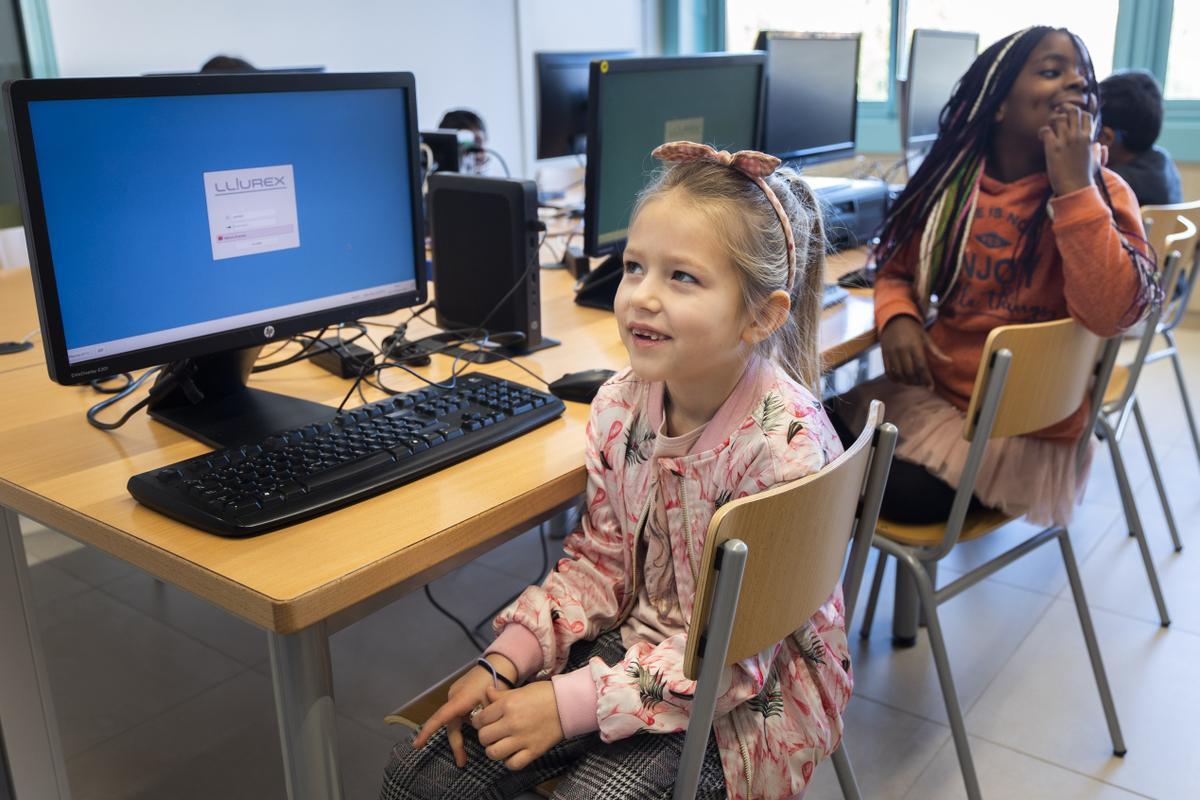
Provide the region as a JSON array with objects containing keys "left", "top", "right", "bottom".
[{"left": 1099, "top": 70, "right": 1183, "bottom": 205}]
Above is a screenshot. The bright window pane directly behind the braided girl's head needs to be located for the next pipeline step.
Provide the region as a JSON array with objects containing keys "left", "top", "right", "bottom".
[{"left": 899, "top": 0, "right": 1118, "bottom": 80}]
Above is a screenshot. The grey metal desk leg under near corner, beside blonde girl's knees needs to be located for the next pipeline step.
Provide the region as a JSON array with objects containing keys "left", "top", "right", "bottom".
[{"left": 266, "top": 622, "right": 342, "bottom": 800}]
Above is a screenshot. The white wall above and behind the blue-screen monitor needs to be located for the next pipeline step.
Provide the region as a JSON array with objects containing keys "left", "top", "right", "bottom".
[{"left": 47, "top": 0, "right": 658, "bottom": 175}]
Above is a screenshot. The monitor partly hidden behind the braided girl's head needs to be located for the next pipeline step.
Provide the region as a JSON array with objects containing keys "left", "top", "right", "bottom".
[{"left": 900, "top": 28, "right": 979, "bottom": 150}]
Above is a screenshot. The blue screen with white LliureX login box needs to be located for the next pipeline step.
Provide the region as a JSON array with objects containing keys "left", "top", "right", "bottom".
[{"left": 29, "top": 89, "right": 415, "bottom": 361}]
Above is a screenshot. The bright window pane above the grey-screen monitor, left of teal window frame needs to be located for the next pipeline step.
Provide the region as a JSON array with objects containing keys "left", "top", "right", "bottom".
[{"left": 725, "top": 0, "right": 892, "bottom": 101}]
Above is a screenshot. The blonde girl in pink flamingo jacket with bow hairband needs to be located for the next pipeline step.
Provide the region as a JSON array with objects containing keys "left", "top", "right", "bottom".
[{"left": 380, "top": 143, "right": 851, "bottom": 800}]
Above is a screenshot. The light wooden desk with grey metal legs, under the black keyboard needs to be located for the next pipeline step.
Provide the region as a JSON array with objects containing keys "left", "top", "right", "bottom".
[{"left": 0, "top": 263, "right": 874, "bottom": 800}]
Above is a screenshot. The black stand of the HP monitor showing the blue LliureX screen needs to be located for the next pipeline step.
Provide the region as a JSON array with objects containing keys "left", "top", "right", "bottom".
[{"left": 148, "top": 345, "right": 334, "bottom": 447}]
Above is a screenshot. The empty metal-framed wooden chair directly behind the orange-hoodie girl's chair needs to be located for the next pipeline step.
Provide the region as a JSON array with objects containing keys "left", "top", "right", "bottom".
[{"left": 1096, "top": 250, "right": 1196, "bottom": 627}]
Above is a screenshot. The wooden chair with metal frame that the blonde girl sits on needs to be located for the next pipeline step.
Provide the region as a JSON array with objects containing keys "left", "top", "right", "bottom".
[{"left": 673, "top": 402, "right": 896, "bottom": 800}]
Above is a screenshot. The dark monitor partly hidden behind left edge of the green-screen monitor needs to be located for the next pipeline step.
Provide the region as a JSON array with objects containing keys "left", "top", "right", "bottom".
[{"left": 533, "top": 50, "right": 634, "bottom": 158}]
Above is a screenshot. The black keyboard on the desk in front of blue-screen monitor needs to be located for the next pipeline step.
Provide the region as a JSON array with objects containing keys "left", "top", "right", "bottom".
[{"left": 128, "top": 373, "right": 563, "bottom": 536}]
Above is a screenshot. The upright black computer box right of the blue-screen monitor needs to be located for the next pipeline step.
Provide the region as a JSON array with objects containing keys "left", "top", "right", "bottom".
[{"left": 430, "top": 173, "right": 558, "bottom": 360}]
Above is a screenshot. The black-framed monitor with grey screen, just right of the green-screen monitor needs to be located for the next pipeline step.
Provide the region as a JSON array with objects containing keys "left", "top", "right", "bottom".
[{"left": 755, "top": 30, "right": 863, "bottom": 163}]
